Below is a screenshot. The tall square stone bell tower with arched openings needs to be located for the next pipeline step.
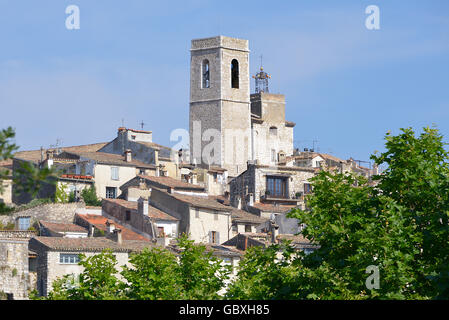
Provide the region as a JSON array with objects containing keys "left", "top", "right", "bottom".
[{"left": 189, "top": 36, "right": 252, "bottom": 176}]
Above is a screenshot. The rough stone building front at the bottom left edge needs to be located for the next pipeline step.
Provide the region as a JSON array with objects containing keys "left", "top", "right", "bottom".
[{"left": 0, "top": 230, "right": 36, "bottom": 300}]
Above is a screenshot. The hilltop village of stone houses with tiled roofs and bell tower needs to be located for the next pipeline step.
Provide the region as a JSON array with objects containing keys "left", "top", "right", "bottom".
[{"left": 0, "top": 36, "right": 377, "bottom": 299}]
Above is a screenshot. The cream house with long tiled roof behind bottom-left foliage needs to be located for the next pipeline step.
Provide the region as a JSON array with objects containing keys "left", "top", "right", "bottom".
[{"left": 29, "top": 235, "right": 154, "bottom": 296}]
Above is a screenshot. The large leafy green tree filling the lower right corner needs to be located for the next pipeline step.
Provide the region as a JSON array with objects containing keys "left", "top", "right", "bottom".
[{"left": 228, "top": 128, "right": 449, "bottom": 299}]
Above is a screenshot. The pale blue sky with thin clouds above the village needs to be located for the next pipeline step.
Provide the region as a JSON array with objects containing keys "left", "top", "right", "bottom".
[{"left": 0, "top": 0, "right": 449, "bottom": 164}]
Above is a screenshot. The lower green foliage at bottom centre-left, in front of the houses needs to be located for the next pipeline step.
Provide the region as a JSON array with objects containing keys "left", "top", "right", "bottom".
[{"left": 41, "top": 236, "right": 230, "bottom": 300}]
